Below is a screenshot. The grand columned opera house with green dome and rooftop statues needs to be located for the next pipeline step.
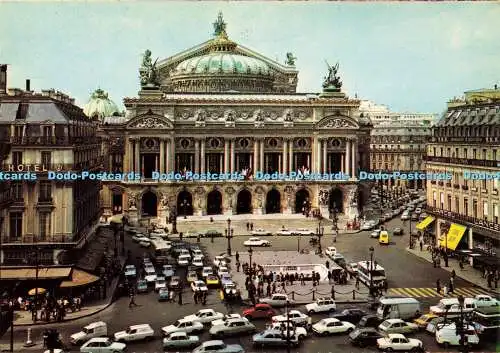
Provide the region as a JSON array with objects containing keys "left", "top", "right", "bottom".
[{"left": 102, "top": 15, "right": 371, "bottom": 223}]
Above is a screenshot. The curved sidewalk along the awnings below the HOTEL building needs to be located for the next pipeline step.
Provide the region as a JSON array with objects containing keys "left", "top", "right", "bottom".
[{"left": 14, "top": 256, "right": 125, "bottom": 326}]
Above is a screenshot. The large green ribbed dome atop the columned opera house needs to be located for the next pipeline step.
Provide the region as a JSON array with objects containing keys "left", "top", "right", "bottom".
[{"left": 173, "top": 52, "right": 271, "bottom": 76}]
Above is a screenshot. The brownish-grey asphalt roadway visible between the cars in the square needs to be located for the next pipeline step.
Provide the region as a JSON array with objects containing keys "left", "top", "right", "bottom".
[{"left": 2, "top": 213, "right": 495, "bottom": 353}]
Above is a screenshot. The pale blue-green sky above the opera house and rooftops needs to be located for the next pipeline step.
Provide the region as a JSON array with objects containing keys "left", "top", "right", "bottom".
[{"left": 0, "top": 1, "right": 500, "bottom": 112}]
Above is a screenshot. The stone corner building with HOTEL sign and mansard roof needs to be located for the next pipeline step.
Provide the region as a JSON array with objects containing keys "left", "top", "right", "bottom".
[{"left": 0, "top": 67, "right": 102, "bottom": 265}]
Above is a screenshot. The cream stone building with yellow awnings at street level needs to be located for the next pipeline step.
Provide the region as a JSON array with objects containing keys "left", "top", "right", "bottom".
[{"left": 426, "top": 87, "right": 500, "bottom": 256}]
